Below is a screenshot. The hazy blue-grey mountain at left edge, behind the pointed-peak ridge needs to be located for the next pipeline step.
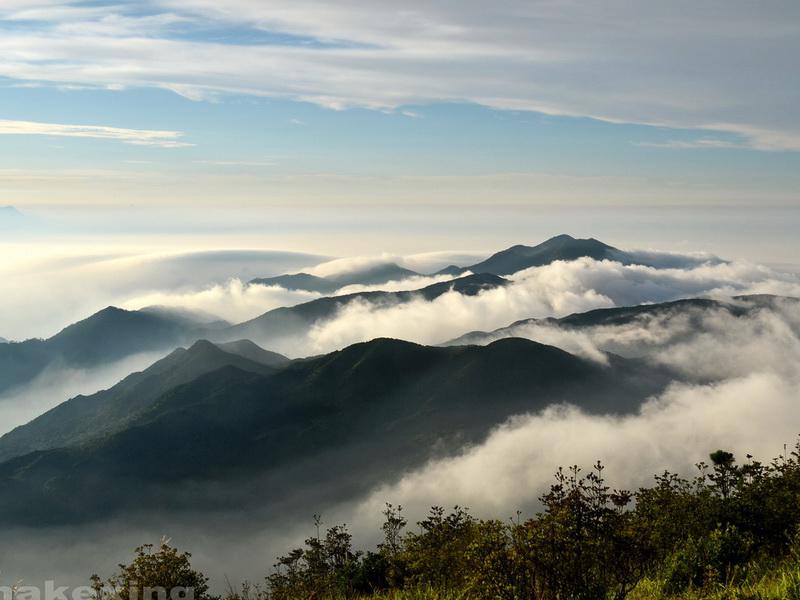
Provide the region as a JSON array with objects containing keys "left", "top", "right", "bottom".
[{"left": 0, "top": 306, "right": 219, "bottom": 392}]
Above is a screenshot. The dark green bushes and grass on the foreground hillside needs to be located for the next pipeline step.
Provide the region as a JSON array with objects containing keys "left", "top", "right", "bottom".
[{"left": 90, "top": 443, "right": 800, "bottom": 600}]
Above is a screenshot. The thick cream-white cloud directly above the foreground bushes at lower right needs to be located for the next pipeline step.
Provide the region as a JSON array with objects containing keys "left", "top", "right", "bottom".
[{"left": 355, "top": 374, "right": 800, "bottom": 518}]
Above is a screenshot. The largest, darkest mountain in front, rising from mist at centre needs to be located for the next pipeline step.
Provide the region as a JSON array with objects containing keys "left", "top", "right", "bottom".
[{"left": 0, "top": 339, "right": 667, "bottom": 526}]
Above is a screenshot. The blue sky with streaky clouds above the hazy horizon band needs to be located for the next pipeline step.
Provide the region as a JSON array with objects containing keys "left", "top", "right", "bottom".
[{"left": 0, "top": 0, "right": 800, "bottom": 206}]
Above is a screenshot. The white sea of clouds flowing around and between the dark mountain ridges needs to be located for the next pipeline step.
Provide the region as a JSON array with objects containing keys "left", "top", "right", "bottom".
[{"left": 0, "top": 241, "right": 800, "bottom": 581}]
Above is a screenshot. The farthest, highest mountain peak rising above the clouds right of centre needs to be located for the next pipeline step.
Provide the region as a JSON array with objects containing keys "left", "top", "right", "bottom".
[{"left": 439, "top": 234, "right": 636, "bottom": 275}]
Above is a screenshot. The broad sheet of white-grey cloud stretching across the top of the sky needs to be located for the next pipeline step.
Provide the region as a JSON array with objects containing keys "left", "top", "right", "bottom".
[{"left": 0, "top": 0, "right": 800, "bottom": 150}]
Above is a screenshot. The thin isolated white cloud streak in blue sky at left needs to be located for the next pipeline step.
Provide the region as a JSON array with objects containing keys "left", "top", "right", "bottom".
[{"left": 0, "top": 119, "right": 194, "bottom": 148}]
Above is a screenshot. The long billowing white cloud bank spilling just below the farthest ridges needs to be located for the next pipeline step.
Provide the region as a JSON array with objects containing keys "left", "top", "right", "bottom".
[{"left": 288, "top": 258, "right": 800, "bottom": 357}]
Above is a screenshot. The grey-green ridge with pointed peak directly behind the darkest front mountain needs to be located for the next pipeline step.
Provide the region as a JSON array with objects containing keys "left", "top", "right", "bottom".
[{"left": 0, "top": 340, "right": 289, "bottom": 462}]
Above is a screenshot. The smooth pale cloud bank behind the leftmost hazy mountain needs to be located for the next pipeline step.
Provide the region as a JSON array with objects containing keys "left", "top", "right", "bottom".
[{"left": 0, "top": 246, "right": 322, "bottom": 340}]
